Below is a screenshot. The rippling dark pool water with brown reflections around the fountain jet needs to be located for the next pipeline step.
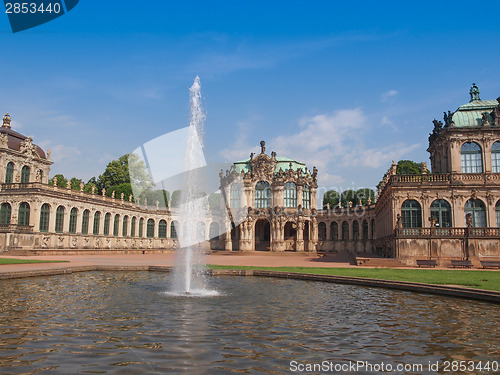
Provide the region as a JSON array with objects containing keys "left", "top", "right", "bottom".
[{"left": 0, "top": 272, "right": 500, "bottom": 374}]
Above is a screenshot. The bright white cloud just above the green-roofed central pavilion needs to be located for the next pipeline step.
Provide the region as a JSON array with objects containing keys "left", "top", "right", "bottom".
[{"left": 221, "top": 108, "right": 420, "bottom": 189}]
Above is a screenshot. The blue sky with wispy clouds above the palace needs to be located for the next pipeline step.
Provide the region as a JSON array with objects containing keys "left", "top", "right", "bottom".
[{"left": 0, "top": 0, "right": 500, "bottom": 200}]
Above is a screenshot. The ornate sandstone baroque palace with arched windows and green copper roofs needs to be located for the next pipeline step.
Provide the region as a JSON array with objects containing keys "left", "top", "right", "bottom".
[{"left": 0, "top": 85, "right": 500, "bottom": 265}]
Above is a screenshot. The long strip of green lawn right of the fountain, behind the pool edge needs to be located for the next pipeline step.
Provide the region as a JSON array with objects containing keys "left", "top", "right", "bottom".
[{"left": 208, "top": 265, "right": 500, "bottom": 291}]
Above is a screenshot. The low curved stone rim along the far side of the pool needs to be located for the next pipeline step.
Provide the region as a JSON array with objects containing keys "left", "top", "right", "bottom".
[{"left": 0, "top": 265, "right": 500, "bottom": 304}]
